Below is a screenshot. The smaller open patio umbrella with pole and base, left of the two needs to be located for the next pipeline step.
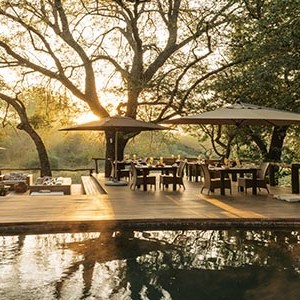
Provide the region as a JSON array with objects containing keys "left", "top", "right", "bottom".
[{"left": 60, "top": 116, "right": 169, "bottom": 185}]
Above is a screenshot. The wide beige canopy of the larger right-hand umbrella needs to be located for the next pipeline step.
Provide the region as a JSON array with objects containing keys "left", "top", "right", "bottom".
[{"left": 163, "top": 102, "right": 300, "bottom": 126}]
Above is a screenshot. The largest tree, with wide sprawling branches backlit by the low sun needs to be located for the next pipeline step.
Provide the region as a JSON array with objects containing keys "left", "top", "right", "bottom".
[{"left": 0, "top": 0, "right": 238, "bottom": 175}]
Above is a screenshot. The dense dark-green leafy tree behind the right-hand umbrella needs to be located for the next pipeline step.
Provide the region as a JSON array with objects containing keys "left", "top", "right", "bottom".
[{"left": 203, "top": 0, "right": 300, "bottom": 161}]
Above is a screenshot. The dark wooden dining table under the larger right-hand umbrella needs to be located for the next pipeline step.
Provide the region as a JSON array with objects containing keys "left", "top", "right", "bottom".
[{"left": 211, "top": 166, "right": 259, "bottom": 196}]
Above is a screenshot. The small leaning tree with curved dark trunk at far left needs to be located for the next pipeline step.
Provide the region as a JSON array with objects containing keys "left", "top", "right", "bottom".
[{"left": 0, "top": 85, "right": 79, "bottom": 176}]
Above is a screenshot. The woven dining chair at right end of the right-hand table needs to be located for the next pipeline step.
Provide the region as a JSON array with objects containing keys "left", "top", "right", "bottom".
[{"left": 238, "top": 162, "right": 270, "bottom": 194}]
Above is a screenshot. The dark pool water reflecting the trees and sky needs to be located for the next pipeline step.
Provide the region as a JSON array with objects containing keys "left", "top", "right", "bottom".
[{"left": 0, "top": 229, "right": 300, "bottom": 300}]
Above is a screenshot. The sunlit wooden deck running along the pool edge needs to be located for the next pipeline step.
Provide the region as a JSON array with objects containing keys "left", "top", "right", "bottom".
[{"left": 0, "top": 175, "right": 300, "bottom": 234}]
